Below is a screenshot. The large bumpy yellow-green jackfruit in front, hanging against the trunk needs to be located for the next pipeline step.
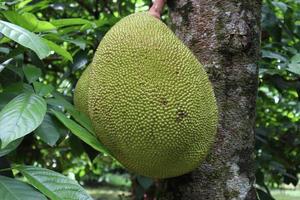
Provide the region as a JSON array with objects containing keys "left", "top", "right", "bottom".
[{"left": 74, "top": 13, "right": 218, "bottom": 178}]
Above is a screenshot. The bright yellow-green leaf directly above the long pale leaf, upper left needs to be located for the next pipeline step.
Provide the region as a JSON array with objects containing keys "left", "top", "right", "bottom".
[{"left": 2, "top": 11, "right": 56, "bottom": 32}]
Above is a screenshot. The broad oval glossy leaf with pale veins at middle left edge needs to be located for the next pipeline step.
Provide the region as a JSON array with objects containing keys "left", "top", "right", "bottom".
[{"left": 0, "top": 93, "right": 47, "bottom": 148}]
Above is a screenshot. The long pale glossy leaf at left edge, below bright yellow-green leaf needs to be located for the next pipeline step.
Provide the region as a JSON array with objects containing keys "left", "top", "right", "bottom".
[{"left": 0, "top": 20, "right": 50, "bottom": 59}]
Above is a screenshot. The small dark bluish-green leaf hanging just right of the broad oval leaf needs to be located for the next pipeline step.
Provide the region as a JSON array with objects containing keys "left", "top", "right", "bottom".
[{"left": 34, "top": 114, "right": 61, "bottom": 146}]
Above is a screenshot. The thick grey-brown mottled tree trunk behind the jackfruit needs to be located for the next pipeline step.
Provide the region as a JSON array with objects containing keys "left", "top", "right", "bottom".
[{"left": 161, "top": 0, "right": 261, "bottom": 200}]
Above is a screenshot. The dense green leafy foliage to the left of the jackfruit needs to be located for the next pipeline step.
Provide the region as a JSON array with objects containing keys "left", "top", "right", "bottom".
[{"left": 0, "top": 0, "right": 150, "bottom": 199}]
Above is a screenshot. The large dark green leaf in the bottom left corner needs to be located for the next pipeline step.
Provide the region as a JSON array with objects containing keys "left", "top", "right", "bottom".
[{"left": 0, "top": 176, "right": 47, "bottom": 200}]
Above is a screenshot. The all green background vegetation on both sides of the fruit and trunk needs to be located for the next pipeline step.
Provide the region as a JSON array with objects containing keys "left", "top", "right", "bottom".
[{"left": 0, "top": 0, "right": 300, "bottom": 200}]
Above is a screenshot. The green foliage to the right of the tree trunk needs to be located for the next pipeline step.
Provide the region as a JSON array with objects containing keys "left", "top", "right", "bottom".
[{"left": 256, "top": 0, "right": 300, "bottom": 199}]
